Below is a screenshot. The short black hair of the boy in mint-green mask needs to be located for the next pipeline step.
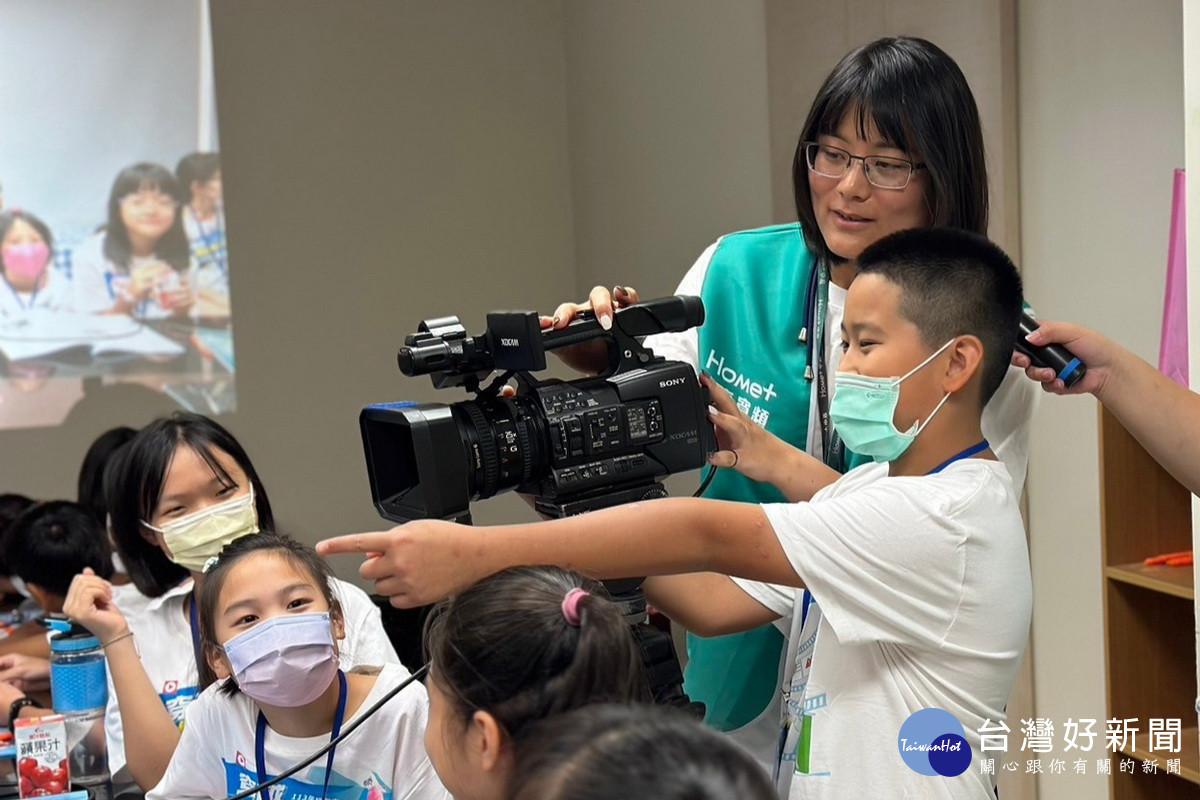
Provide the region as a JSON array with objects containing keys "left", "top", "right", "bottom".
[{"left": 858, "top": 228, "right": 1024, "bottom": 405}]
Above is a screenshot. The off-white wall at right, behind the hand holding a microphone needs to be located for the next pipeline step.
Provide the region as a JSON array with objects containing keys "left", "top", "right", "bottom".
[{"left": 1018, "top": 0, "right": 1183, "bottom": 800}]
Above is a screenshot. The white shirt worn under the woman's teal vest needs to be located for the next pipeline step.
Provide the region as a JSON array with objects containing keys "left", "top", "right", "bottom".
[{"left": 644, "top": 239, "right": 1040, "bottom": 498}]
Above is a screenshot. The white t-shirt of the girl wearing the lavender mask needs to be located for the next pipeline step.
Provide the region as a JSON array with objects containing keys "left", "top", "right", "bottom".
[{"left": 146, "top": 666, "right": 449, "bottom": 800}]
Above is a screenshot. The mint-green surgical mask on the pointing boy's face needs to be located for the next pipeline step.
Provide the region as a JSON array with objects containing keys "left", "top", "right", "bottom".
[{"left": 829, "top": 339, "right": 954, "bottom": 462}]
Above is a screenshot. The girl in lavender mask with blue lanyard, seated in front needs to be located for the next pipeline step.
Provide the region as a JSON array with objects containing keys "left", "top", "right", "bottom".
[{"left": 146, "top": 534, "right": 446, "bottom": 800}]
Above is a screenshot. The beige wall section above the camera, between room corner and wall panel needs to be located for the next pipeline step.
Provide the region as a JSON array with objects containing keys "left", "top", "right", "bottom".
[{"left": 565, "top": 0, "right": 772, "bottom": 296}]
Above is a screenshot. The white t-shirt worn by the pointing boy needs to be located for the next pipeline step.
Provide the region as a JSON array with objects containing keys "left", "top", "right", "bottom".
[{"left": 736, "top": 458, "right": 1032, "bottom": 800}]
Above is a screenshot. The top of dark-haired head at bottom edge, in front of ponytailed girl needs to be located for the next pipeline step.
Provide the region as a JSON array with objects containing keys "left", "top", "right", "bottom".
[{"left": 509, "top": 705, "right": 779, "bottom": 800}]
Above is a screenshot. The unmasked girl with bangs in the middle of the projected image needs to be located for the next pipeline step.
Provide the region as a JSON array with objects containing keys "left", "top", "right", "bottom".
[{"left": 72, "top": 163, "right": 193, "bottom": 319}]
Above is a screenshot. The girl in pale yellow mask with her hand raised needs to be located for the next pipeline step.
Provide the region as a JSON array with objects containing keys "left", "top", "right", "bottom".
[{"left": 64, "top": 413, "right": 398, "bottom": 792}]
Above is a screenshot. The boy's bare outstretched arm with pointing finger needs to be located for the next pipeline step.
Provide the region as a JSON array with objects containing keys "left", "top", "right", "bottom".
[{"left": 317, "top": 498, "right": 799, "bottom": 608}]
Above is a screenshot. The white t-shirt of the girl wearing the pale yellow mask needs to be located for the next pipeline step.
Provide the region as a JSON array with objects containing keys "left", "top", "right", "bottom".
[{"left": 104, "top": 578, "right": 407, "bottom": 800}]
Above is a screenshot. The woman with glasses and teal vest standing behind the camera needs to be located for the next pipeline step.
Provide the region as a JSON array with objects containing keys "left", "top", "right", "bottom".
[{"left": 542, "top": 37, "right": 1034, "bottom": 772}]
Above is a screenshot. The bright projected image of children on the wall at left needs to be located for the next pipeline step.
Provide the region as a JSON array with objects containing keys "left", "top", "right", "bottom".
[{"left": 0, "top": 0, "right": 236, "bottom": 429}]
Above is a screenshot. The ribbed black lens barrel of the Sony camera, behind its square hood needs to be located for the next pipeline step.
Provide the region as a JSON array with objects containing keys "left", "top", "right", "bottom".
[{"left": 454, "top": 397, "right": 550, "bottom": 500}]
